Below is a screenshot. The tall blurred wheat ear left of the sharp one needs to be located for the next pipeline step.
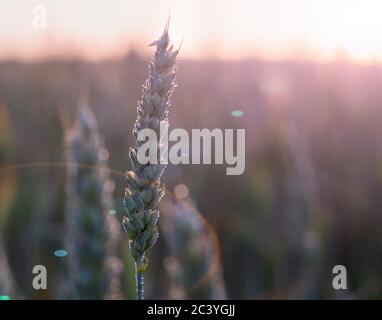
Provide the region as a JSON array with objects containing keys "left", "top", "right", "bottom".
[{"left": 66, "top": 102, "right": 120, "bottom": 299}]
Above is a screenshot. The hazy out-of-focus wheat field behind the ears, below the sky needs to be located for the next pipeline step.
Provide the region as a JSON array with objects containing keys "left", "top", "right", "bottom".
[{"left": 0, "top": 51, "right": 382, "bottom": 299}]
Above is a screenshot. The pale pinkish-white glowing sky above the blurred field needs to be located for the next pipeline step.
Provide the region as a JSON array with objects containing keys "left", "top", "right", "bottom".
[{"left": 0, "top": 0, "right": 382, "bottom": 61}]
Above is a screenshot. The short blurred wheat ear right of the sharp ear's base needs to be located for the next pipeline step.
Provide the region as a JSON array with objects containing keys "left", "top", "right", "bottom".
[{"left": 160, "top": 196, "right": 227, "bottom": 300}]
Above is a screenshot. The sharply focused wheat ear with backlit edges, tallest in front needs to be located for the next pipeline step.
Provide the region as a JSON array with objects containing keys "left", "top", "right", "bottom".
[{"left": 123, "top": 22, "right": 179, "bottom": 300}]
